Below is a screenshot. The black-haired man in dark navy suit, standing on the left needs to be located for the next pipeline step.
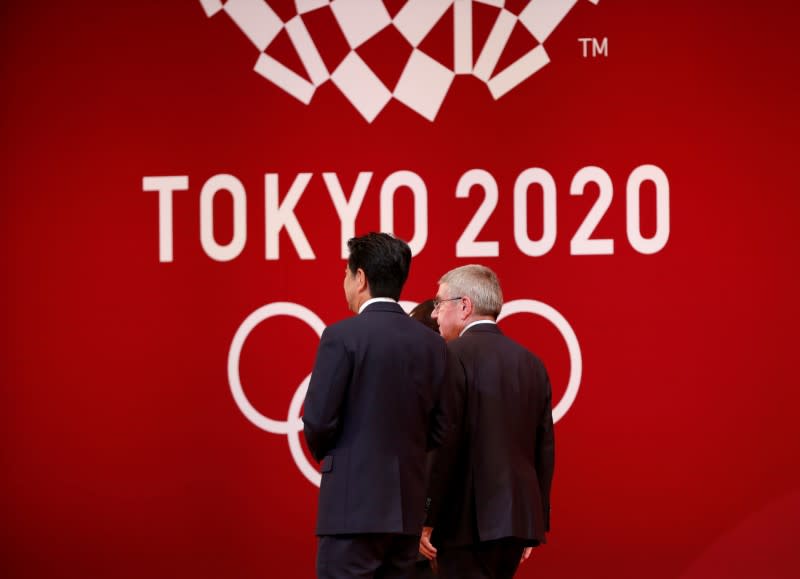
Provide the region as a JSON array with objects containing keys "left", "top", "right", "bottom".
[{"left": 303, "top": 233, "right": 447, "bottom": 579}]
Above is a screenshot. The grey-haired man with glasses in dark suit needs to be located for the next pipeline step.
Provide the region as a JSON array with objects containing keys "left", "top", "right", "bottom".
[{"left": 420, "top": 265, "right": 554, "bottom": 579}]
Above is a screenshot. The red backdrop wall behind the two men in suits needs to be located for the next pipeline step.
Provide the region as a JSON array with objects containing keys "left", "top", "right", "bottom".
[{"left": 0, "top": 0, "right": 800, "bottom": 578}]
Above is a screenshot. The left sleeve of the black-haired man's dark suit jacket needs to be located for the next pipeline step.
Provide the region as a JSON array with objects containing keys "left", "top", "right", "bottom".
[{"left": 303, "top": 329, "right": 352, "bottom": 462}]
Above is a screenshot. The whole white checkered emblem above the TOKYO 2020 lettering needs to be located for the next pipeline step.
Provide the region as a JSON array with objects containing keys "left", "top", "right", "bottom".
[{"left": 200, "top": 0, "right": 600, "bottom": 123}]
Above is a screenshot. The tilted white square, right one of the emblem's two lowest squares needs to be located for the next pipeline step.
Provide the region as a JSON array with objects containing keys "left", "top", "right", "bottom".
[{"left": 394, "top": 48, "right": 455, "bottom": 121}]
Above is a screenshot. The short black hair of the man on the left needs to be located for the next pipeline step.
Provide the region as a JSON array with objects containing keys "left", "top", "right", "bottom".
[{"left": 347, "top": 233, "right": 411, "bottom": 300}]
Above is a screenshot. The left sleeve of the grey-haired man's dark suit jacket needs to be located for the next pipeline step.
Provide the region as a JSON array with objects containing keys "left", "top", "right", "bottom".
[{"left": 425, "top": 351, "right": 467, "bottom": 527}]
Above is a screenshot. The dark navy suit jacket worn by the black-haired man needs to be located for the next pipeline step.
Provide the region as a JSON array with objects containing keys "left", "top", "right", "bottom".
[{"left": 303, "top": 302, "right": 447, "bottom": 535}]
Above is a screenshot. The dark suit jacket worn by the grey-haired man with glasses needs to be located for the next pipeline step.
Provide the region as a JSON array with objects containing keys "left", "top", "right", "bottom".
[{"left": 426, "top": 324, "right": 555, "bottom": 546}]
